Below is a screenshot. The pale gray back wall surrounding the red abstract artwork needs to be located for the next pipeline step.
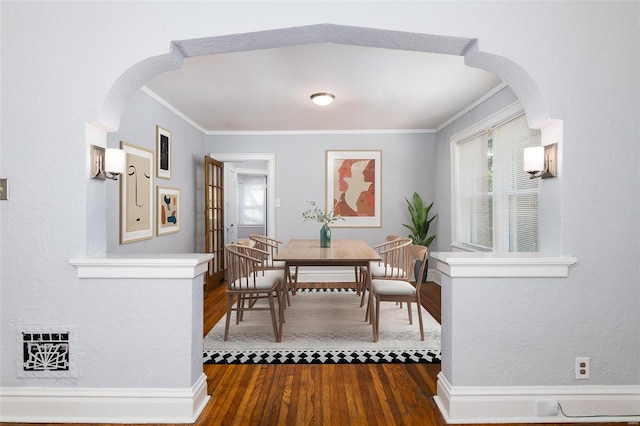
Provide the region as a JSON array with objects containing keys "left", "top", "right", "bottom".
[{"left": 207, "top": 133, "right": 436, "bottom": 244}]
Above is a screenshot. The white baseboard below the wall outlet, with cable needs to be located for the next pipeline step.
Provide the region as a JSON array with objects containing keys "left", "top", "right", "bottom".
[{"left": 434, "top": 373, "right": 640, "bottom": 424}]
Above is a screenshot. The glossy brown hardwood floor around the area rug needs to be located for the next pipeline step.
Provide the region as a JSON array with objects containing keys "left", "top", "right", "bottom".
[{"left": 1, "top": 283, "right": 624, "bottom": 426}]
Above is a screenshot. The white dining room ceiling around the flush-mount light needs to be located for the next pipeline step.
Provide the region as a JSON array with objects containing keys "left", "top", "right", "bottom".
[{"left": 145, "top": 43, "right": 502, "bottom": 133}]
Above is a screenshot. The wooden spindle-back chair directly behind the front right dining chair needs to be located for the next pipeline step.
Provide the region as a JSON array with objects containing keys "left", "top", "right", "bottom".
[{"left": 358, "top": 237, "right": 412, "bottom": 320}]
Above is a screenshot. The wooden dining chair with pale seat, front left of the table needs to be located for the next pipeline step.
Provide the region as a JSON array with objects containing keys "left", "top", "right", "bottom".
[{"left": 224, "top": 244, "right": 284, "bottom": 342}]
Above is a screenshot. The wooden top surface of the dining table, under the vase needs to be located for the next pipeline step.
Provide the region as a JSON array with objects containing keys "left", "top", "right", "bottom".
[{"left": 273, "top": 238, "right": 380, "bottom": 265}]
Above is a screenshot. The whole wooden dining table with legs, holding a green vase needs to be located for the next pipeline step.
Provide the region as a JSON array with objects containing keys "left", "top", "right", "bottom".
[{"left": 273, "top": 239, "right": 381, "bottom": 339}]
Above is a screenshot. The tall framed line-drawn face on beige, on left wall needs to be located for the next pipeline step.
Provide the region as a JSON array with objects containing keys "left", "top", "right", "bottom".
[{"left": 120, "top": 141, "right": 153, "bottom": 244}]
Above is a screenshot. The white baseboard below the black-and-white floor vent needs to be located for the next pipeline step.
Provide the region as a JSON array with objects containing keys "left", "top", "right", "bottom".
[{"left": 0, "top": 373, "right": 210, "bottom": 423}]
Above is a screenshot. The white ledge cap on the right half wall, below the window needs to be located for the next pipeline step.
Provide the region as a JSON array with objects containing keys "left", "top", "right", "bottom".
[{"left": 429, "top": 252, "right": 577, "bottom": 278}]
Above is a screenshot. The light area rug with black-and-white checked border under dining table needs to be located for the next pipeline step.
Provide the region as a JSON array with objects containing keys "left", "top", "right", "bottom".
[{"left": 204, "top": 289, "right": 440, "bottom": 364}]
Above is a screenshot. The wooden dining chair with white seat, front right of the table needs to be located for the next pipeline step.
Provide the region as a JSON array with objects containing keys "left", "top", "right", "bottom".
[{"left": 370, "top": 244, "right": 428, "bottom": 342}]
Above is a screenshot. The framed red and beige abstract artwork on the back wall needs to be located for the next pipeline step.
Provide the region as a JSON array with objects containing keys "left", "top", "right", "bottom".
[{"left": 326, "top": 151, "right": 382, "bottom": 227}]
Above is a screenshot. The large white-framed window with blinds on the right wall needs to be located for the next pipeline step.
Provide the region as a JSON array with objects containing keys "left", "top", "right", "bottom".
[{"left": 452, "top": 109, "right": 540, "bottom": 252}]
